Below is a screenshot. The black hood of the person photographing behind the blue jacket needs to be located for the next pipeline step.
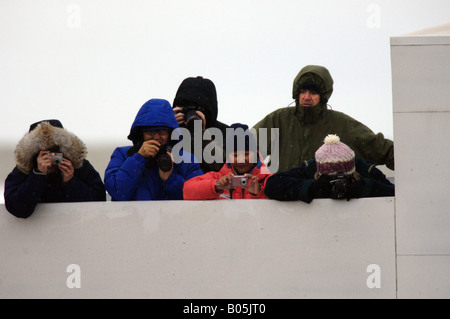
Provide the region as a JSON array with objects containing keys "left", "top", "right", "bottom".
[{"left": 172, "top": 76, "right": 218, "bottom": 128}]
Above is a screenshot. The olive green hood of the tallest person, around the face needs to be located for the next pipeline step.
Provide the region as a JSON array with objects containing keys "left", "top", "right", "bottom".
[{"left": 292, "top": 65, "right": 334, "bottom": 123}]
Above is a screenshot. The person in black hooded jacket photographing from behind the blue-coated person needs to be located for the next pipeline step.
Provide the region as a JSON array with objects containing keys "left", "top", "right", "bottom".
[{"left": 172, "top": 76, "right": 229, "bottom": 173}]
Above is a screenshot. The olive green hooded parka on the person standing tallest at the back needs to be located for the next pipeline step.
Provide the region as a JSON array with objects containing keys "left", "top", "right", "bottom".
[{"left": 253, "top": 65, "right": 394, "bottom": 173}]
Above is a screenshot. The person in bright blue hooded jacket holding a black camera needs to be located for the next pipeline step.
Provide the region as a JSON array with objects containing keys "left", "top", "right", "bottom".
[{"left": 105, "top": 99, "right": 203, "bottom": 201}]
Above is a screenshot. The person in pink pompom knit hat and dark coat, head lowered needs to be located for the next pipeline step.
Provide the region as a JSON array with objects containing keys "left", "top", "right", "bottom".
[{"left": 265, "top": 134, "right": 395, "bottom": 203}]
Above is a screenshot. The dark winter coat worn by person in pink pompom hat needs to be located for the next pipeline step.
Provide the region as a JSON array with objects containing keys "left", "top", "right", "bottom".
[{"left": 265, "top": 158, "right": 395, "bottom": 203}]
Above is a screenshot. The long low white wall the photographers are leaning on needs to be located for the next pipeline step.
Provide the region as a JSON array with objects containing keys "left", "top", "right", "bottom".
[{"left": 0, "top": 197, "right": 396, "bottom": 299}]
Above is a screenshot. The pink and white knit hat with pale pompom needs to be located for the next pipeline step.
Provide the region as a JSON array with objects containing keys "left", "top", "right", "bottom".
[{"left": 315, "top": 134, "right": 355, "bottom": 175}]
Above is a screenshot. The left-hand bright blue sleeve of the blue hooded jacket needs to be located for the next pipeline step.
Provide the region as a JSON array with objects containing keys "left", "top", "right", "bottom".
[{"left": 105, "top": 147, "right": 146, "bottom": 201}]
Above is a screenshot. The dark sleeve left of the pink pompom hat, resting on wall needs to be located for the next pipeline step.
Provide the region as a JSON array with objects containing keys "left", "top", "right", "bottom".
[{"left": 264, "top": 163, "right": 314, "bottom": 203}]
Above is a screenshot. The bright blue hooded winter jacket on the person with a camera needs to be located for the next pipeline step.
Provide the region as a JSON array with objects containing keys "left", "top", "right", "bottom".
[{"left": 105, "top": 99, "right": 203, "bottom": 201}]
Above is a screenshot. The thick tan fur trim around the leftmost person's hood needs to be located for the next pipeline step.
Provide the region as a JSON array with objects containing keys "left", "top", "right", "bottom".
[{"left": 15, "top": 122, "right": 87, "bottom": 174}]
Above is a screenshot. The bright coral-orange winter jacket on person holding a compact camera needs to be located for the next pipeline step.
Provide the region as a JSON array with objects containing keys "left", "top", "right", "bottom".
[{"left": 183, "top": 160, "right": 272, "bottom": 200}]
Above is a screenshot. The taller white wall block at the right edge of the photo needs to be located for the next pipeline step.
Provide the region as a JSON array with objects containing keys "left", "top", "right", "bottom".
[{"left": 391, "top": 24, "right": 450, "bottom": 298}]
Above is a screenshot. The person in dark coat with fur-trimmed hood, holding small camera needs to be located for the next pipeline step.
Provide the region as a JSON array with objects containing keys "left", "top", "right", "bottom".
[{"left": 4, "top": 120, "right": 106, "bottom": 218}]
